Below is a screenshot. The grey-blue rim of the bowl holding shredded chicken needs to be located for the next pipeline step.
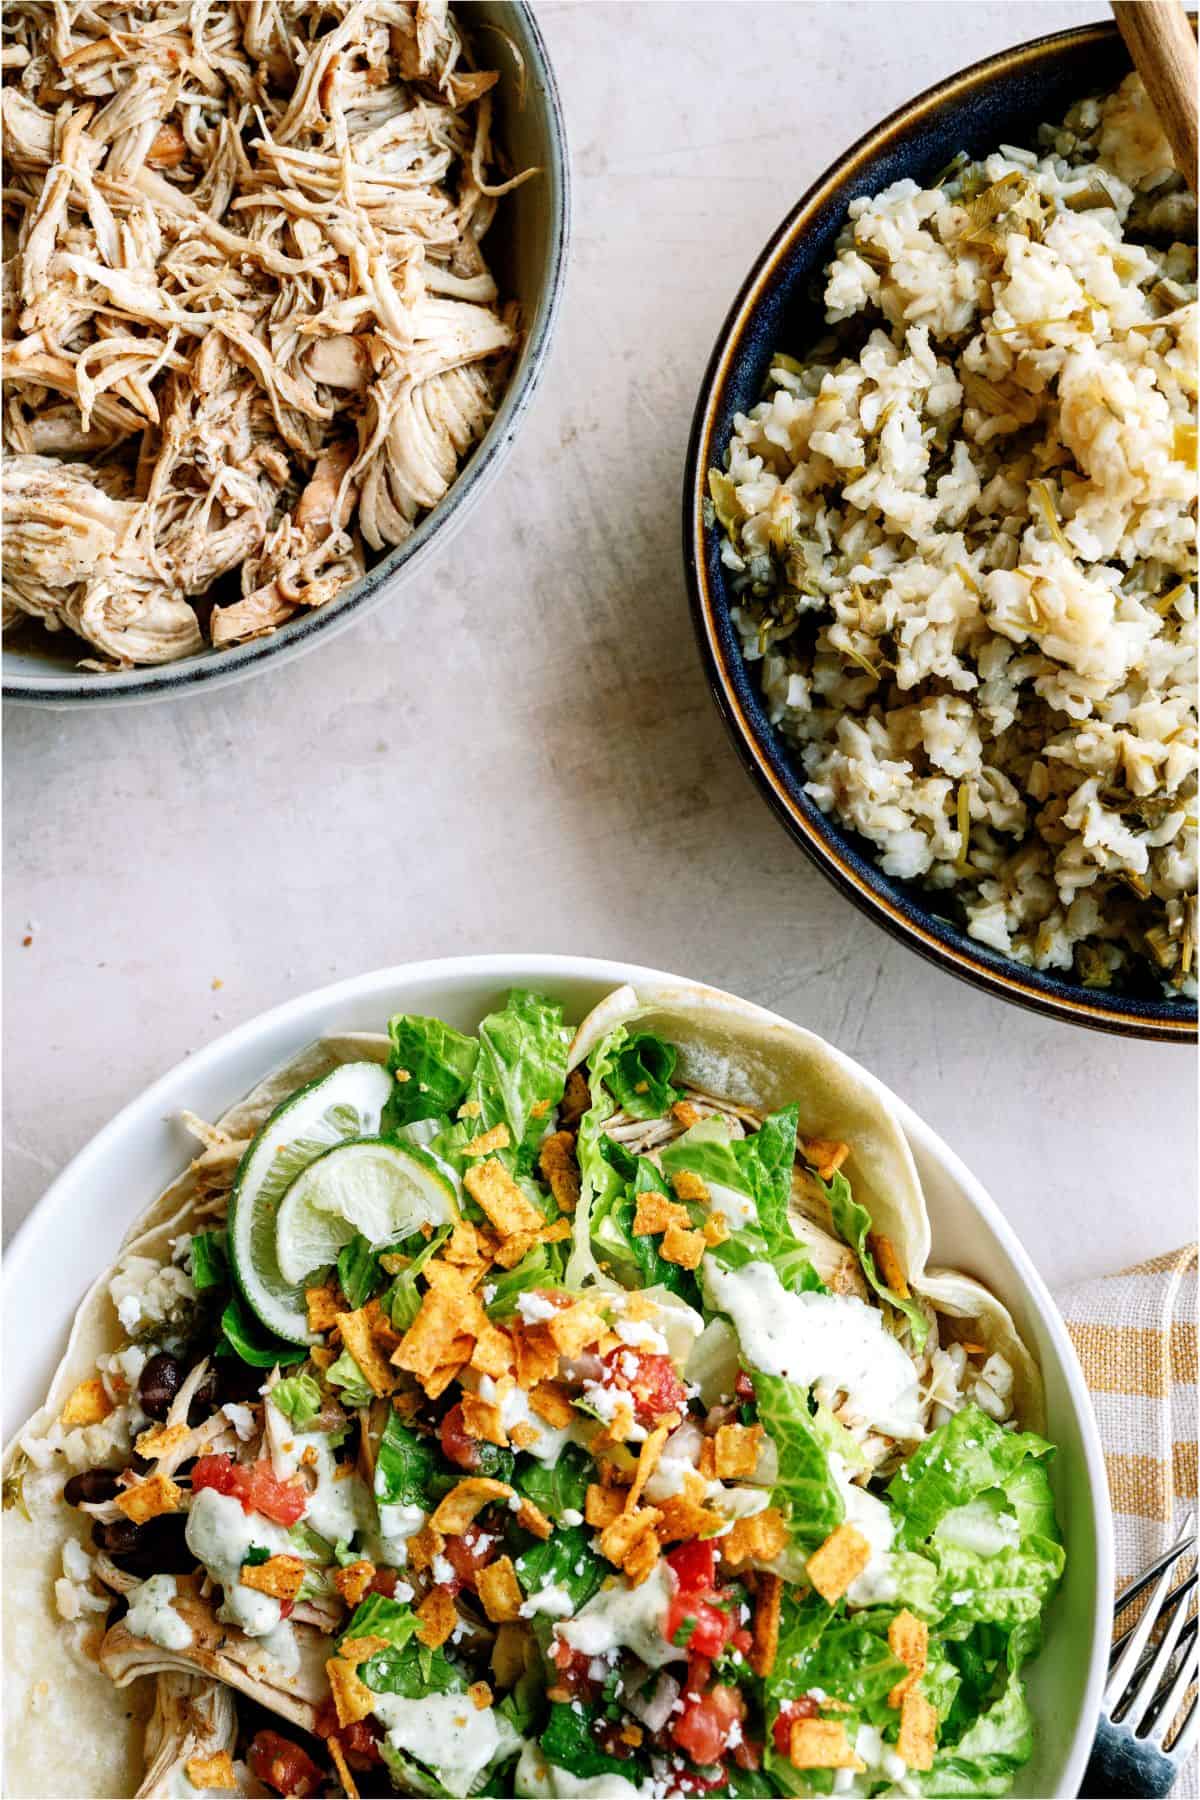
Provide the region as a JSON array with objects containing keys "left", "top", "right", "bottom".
[{"left": 2, "top": 0, "right": 570, "bottom": 709}]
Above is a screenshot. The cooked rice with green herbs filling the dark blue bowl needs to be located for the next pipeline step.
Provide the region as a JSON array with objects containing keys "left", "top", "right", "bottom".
[{"left": 694, "top": 28, "right": 1196, "bottom": 1024}]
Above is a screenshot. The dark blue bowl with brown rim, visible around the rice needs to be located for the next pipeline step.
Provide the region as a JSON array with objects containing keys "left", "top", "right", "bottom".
[{"left": 684, "top": 25, "right": 1196, "bottom": 1040}]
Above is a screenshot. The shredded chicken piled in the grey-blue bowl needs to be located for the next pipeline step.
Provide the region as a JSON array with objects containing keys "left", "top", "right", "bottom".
[{"left": 0, "top": 0, "right": 536, "bottom": 668}]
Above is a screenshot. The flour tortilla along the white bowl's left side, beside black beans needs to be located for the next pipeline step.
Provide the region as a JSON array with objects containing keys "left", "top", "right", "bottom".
[{"left": 2, "top": 1033, "right": 389, "bottom": 1800}]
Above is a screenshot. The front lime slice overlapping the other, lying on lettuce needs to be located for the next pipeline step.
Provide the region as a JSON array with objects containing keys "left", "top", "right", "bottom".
[{"left": 275, "top": 1138, "right": 459, "bottom": 1282}]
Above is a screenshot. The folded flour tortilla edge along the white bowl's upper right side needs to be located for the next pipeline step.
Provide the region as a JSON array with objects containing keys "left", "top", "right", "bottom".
[{"left": 569, "top": 983, "right": 1045, "bottom": 1431}]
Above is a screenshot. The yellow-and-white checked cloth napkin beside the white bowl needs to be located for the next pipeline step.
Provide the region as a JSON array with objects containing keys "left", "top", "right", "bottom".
[{"left": 1054, "top": 1244, "right": 1200, "bottom": 1800}]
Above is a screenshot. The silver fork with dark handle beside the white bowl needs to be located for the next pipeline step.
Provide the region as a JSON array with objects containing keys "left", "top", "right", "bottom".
[{"left": 1079, "top": 1512, "right": 1200, "bottom": 1800}]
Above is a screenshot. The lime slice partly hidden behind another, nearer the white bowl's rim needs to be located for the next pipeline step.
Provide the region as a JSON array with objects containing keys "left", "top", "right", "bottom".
[{"left": 228, "top": 1062, "right": 392, "bottom": 1345}]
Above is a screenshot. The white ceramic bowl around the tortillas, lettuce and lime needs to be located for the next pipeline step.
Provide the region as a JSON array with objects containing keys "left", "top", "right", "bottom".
[{"left": 4, "top": 954, "right": 1112, "bottom": 1796}]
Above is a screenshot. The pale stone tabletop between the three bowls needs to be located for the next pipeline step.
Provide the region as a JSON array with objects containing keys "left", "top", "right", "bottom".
[{"left": 4, "top": 0, "right": 1195, "bottom": 1283}]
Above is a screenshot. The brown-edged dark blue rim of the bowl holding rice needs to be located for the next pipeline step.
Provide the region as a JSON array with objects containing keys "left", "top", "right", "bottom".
[{"left": 682, "top": 20, "right": 1196, "bottom": 1042}]
